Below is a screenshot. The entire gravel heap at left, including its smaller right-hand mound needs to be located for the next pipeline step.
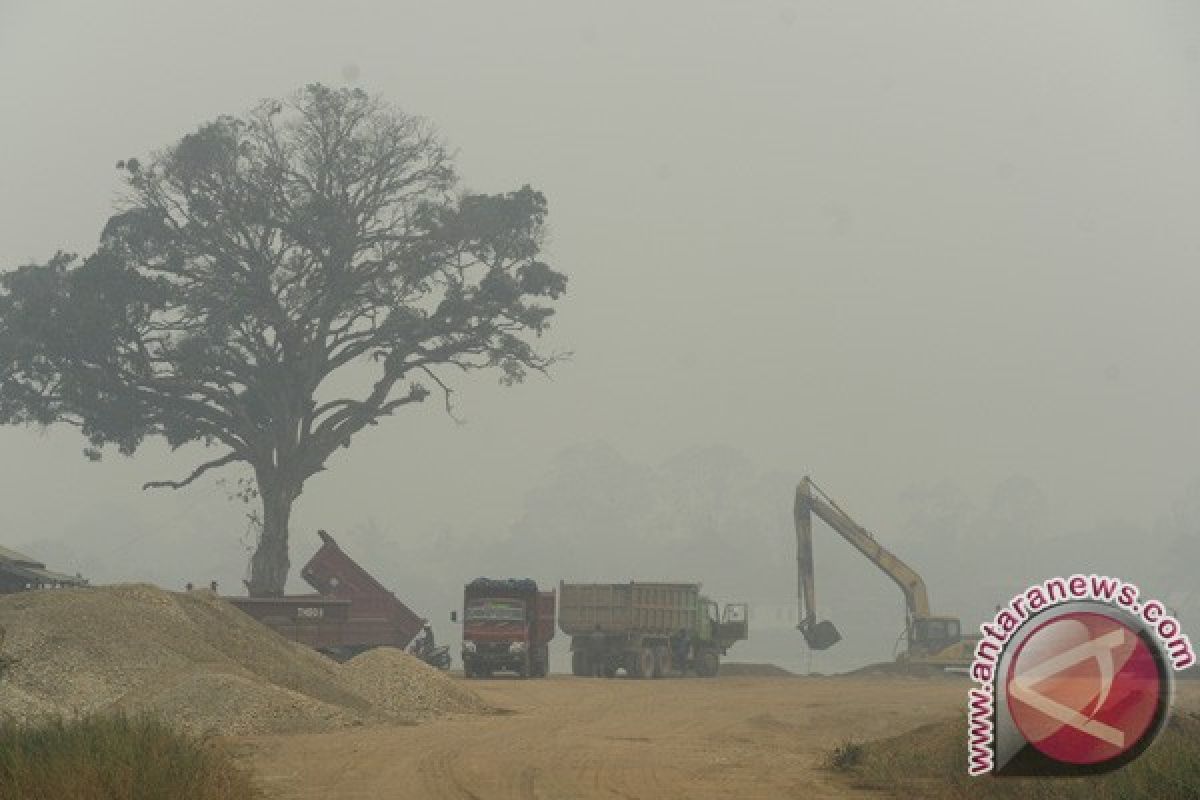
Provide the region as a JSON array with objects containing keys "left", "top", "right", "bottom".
[{"left": 0, "top": 584, "right": 484, "bottom": 734}]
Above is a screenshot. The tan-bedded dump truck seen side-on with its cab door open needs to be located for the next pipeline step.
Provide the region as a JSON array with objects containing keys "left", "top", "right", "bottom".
[{"left": 558, "top": 582, "right": 749, "bottom": 678}]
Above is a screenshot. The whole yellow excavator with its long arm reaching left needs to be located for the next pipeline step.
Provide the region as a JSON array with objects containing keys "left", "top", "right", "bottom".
[{"left": 794, "top": 475, "right": 979, "bottom": 669}]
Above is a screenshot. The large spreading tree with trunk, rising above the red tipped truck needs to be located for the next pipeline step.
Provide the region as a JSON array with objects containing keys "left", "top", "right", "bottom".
[{"left": 0, "top": 85, "right": 566, "bottom": 595}]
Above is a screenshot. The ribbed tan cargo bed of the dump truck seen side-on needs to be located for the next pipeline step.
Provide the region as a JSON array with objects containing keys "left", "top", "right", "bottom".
[{"left": 558, "top": 582, "right": 701, "bottom": 636}]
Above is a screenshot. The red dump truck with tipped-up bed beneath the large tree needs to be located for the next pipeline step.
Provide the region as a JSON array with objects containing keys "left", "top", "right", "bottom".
[{"left": 224, "top": 530, "right": 425, "bottom": 661}]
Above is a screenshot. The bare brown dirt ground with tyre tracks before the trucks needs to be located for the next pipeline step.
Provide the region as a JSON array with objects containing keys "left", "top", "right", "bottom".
[{"left": 239, "top": 676, "right": 1200, "bottom": 800}]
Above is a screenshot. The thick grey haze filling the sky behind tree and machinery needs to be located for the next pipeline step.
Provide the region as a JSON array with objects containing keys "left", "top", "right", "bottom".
[{"left": 0, "top": 0, "right": 1200, "bottom": 668}]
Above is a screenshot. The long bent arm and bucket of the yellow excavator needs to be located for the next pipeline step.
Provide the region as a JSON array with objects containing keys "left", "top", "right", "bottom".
[{"left": 794, "top": 476, "right": 929, "bottom": 650}]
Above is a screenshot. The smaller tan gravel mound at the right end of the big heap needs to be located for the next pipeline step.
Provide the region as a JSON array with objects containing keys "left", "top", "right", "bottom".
[{"left": 341, "top": 648, "right": 486, "bottom": 712}]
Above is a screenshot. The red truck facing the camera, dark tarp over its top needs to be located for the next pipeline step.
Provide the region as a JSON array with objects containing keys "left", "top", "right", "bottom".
[{"left": 462, "top": 578, "right": 554, "bottom": 678}]
